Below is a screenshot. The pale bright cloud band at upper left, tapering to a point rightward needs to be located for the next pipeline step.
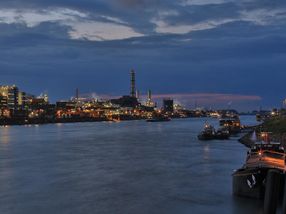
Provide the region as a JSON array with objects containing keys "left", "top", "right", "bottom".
[{"left": 0, "top": 8, "right": 143, "bottom": 41}]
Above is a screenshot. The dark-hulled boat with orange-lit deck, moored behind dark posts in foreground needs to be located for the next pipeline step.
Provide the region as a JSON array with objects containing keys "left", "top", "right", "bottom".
[{"left": 232, "top": 132, "right": 286, "bottom": 199}]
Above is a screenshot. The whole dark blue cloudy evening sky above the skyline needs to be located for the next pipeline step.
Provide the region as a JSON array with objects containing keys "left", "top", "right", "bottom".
[{"left": 0, "top": 0, "right": 286, "bottom": 109}]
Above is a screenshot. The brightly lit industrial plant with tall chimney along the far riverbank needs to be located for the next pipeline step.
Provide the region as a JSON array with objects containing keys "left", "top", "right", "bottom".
[{"left": 0, "top": 69, "right": 197, "bottom": 125}]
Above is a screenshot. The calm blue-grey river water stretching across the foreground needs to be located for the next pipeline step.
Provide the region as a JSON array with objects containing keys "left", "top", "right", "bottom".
[{"left": 0, "top": 117, "right": 261, "bottom": 214}]
